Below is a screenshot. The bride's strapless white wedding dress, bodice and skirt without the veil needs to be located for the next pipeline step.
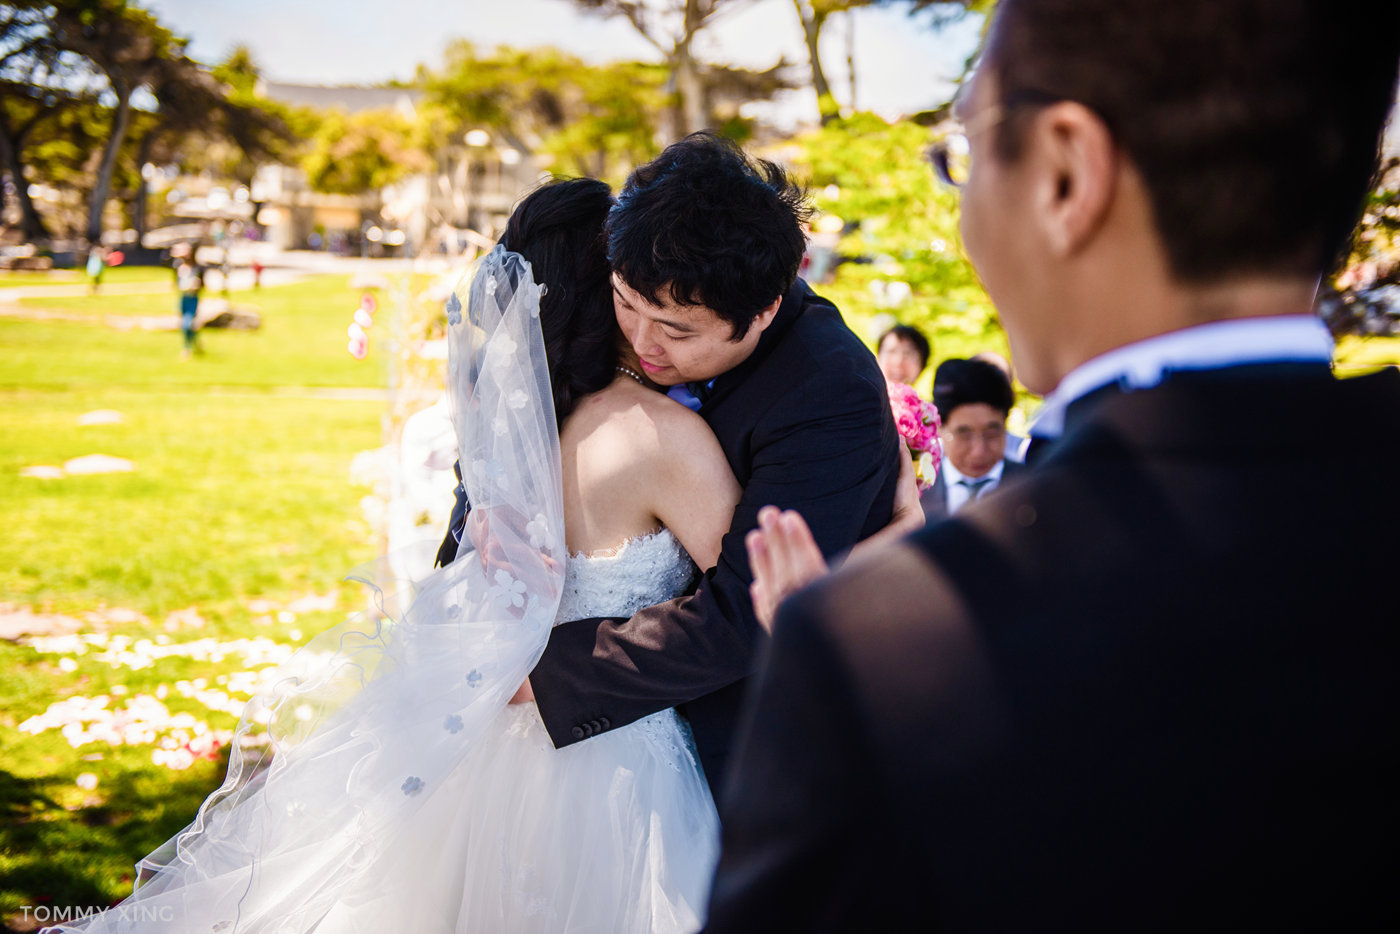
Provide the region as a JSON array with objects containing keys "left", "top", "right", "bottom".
[{"left": 315, "top": 529, "right": 720, "bottom": 934}]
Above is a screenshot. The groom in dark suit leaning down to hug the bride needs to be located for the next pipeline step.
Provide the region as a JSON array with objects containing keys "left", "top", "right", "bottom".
[{"left": 444, "top": 133, "right": 901, "bottom": 800}]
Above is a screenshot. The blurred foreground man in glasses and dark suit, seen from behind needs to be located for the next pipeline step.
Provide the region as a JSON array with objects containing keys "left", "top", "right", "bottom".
[{"left": 710, "top": 0, "right": 1400, "bottom": 933}]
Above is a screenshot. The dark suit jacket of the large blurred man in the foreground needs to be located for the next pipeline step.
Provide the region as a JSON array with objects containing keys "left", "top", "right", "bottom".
[{"left": 707, "top": 365, "right": 1400, "bottom": 933}]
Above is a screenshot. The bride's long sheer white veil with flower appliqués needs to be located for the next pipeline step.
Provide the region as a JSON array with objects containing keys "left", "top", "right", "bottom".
[{"left": 49, "top": 246, "right": 566, "bottom": 934}]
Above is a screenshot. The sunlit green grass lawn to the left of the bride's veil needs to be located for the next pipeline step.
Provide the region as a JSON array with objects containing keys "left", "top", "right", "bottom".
[{"left": 0, "top": 269, "right": 386, "bottom": 930}]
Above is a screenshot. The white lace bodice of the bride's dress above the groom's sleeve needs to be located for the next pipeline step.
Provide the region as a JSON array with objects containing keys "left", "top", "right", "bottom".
[{"left": 556, "top": 529, "right": 696, "bottom": 622}]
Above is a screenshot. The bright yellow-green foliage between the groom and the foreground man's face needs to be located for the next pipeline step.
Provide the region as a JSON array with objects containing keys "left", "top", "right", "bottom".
[{"left": 799, "top": 113, "right": 1005, "bottom": 383}]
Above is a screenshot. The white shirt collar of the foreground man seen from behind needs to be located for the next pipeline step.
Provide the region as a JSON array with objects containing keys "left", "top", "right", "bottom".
[{"left": 1030, "top": 315, "right": 1333, "bottom": 438}]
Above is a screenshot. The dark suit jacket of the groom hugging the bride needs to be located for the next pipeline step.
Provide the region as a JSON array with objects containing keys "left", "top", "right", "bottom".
[{"left": 531, "top": 280, "right": 899, "bottom": 798}]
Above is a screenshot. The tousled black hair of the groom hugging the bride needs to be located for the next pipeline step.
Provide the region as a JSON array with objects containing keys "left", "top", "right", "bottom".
[{"left": 608, "top": 133, "right": 811, "bottom": 340}]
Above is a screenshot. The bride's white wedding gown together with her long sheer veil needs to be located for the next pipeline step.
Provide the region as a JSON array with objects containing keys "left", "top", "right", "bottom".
[{"left": 49, "top": 246, "right": 718, "bottom": 934}]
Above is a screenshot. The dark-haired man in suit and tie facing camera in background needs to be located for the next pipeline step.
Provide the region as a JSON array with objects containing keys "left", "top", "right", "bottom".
[{"left": 920, "top": 358, "right": 1025, "bottom": 521}]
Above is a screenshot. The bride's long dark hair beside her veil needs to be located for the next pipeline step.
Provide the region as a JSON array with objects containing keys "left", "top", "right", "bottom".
[{"left": 500, "top": 178, "right": 617, "bottom": 423}]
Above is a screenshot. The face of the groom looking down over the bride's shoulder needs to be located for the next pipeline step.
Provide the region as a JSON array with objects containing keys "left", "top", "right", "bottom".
[{"left": 613, "top": 273, "right": 781, "bottom": 386}]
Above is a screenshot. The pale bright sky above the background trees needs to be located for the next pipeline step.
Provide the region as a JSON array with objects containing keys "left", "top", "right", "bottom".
[{"left": 143, "top": 0, "right": 980, "bottom": 123}]
